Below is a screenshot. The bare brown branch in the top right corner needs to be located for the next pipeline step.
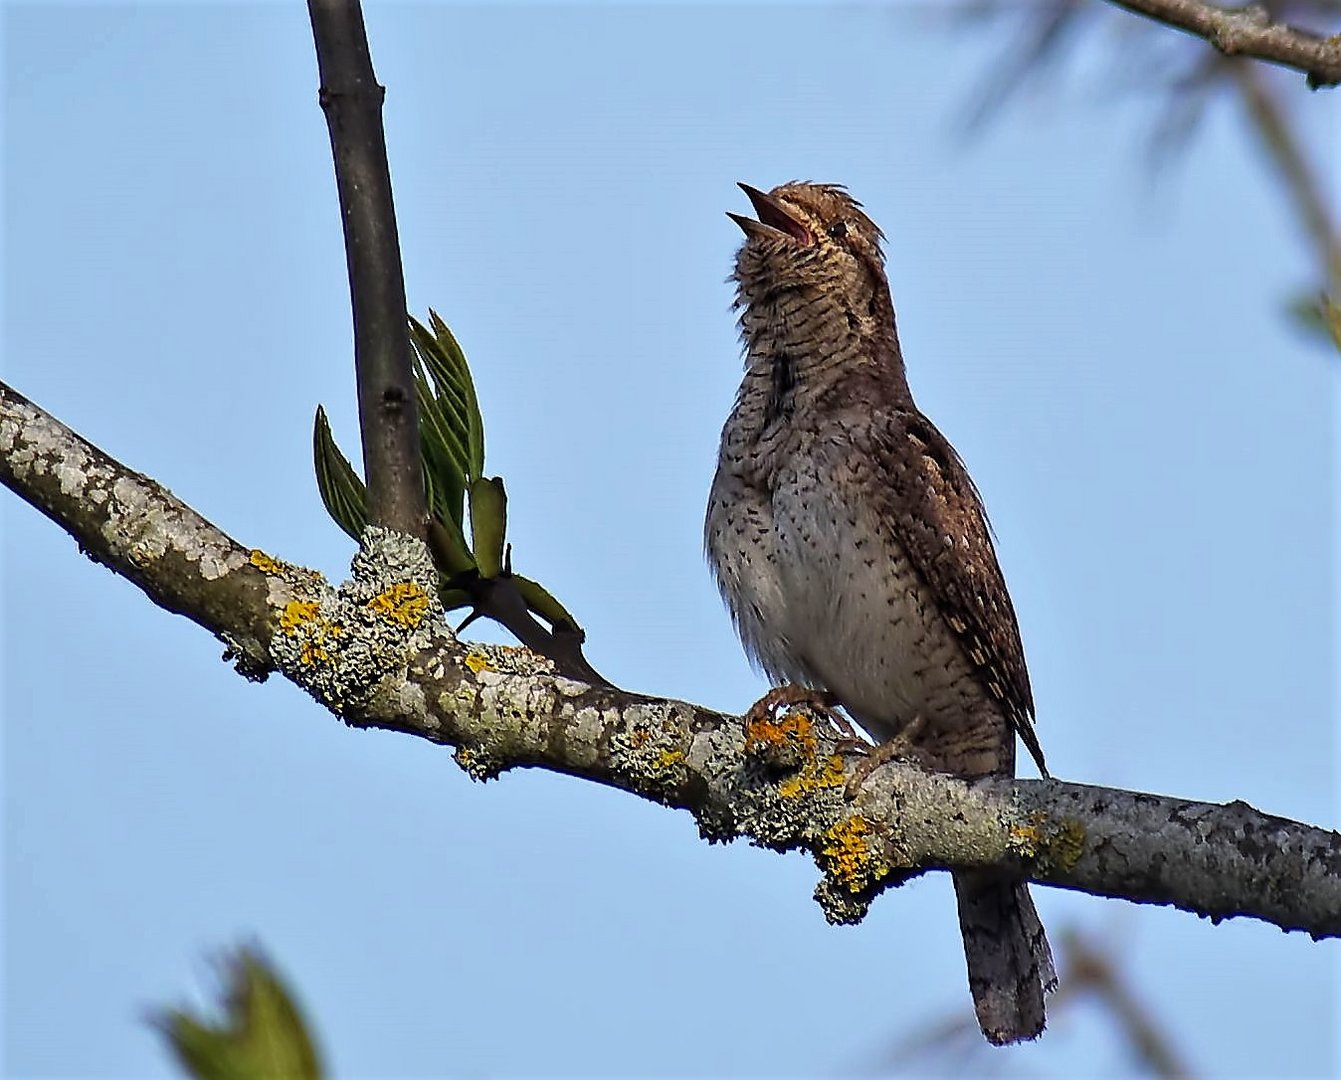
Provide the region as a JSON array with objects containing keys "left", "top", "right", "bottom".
[{"left": 1109, "top": 0, "right": 1341, "bottom": 90}]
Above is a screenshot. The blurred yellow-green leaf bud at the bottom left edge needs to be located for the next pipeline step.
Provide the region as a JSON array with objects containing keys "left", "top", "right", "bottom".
[{"left": 153, "top": 949, "right": 322, "bottom": 1080}]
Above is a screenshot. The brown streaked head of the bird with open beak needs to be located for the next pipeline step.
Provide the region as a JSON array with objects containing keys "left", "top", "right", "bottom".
[{"left": 727, "top": 181, "right": 888, "bottom": 307}]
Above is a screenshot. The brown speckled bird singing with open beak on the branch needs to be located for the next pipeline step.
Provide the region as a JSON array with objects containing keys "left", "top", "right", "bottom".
[{"left": 704, "top": 181, "right": 1057, "bottom": 1045}]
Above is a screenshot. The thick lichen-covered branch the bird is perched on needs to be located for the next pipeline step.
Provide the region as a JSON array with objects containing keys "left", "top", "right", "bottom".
[{"left": 0, "top": 384, "right": 1341, "bottom": 938}]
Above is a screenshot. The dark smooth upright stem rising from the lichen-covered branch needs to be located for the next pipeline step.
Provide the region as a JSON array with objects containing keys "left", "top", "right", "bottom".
[{"left": 307, "top": 0, "right": 428, "bottom": 537}]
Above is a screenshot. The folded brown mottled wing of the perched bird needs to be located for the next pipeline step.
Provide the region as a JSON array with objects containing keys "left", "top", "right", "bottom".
[{"left": 872, "top": 409, "right": 1047, "bottom": 777}]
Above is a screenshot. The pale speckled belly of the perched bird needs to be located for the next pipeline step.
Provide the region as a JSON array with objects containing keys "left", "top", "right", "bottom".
[{"left": 772, "top": 475, "right": 984, "bottom": 739}]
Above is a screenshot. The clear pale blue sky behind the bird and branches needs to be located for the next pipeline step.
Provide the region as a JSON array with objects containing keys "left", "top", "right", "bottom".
[{"left": 0, "top": 4, "right": 1338, "bottom": 1077}]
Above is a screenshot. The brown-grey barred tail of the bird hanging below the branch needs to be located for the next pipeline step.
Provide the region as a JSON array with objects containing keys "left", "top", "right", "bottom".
[{"left": 953, "top": 872, "right": 1057, "bottom": 1046}]
